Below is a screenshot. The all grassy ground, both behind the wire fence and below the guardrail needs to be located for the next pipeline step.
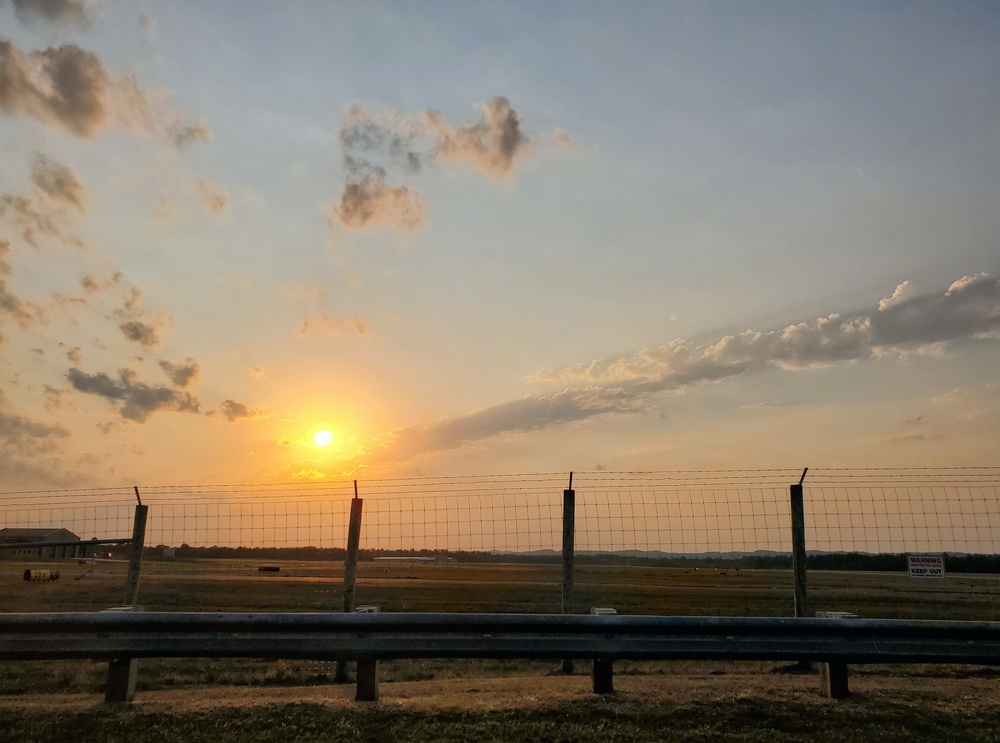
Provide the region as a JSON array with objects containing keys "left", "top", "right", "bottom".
[{"left": 0, "top": 560, "right": 1000, "bottom": 742}]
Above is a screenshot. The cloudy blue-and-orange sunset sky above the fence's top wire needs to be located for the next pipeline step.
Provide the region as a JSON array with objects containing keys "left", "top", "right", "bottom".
[{"left": 0, "top": 0, "right": 1000, "bottom": 492}]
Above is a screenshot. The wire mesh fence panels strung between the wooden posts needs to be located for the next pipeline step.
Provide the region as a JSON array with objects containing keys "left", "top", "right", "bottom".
[{"left": 0, "top": 468, "right": 1000, "bottom": 612}]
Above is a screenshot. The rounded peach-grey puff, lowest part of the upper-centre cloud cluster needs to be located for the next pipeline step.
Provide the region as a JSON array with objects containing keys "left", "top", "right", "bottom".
[{"left": 328, "top": 174, "right": 427, "bottom": 230}]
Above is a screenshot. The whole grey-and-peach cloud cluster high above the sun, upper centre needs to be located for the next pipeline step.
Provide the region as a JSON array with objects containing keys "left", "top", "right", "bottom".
[{"left": 327, "top": 96, "right": 569, "bottom": 230}]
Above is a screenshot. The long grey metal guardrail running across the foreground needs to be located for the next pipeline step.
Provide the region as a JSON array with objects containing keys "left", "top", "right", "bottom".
[{"left": 0, "top": 612, "right": 1000, "bottom": 699}]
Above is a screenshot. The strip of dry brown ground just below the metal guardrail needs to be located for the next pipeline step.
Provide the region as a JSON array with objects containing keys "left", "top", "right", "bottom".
[{"left": 0, "top": 672, "right": 1000, "bottom": 713}]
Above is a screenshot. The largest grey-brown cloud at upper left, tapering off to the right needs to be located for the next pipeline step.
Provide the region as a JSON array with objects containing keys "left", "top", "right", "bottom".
[{"left": 0, "top": 41, "right": 209, "bottom": 146}]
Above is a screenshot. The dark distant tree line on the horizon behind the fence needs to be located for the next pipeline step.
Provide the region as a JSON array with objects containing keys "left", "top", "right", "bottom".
[{"left": 144, "top": 544, "right": 1000, "bottom": 573}]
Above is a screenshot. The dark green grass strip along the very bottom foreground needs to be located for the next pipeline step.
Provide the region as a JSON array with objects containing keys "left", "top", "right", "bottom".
[{"left": 0, "top": 695, "right": 1000, "bottom": 743}]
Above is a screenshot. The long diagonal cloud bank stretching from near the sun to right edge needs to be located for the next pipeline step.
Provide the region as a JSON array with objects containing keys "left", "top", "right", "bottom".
[{"left": 365, "top": 273, "right": 1000, "bottom": 464}]
